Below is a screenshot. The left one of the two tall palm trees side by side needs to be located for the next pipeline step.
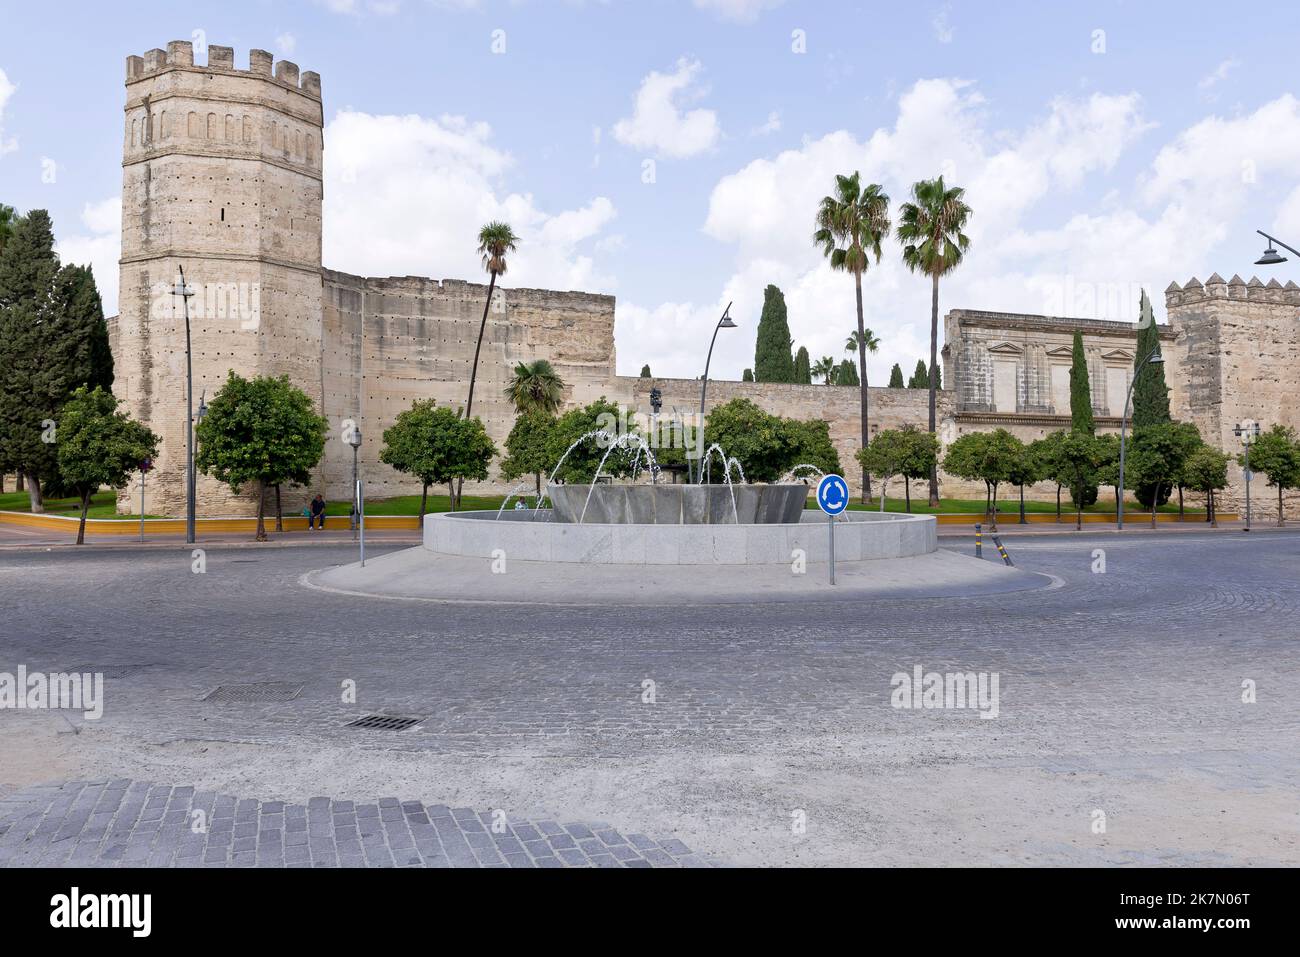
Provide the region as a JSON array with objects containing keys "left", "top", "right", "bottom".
[{"left": 813, "top": 172, "right": 889, "bottom": 502}]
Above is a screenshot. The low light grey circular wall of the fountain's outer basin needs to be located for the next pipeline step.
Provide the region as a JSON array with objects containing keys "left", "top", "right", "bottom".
[{"left": 424, "top": 512, "right": 939, "bottom": 566}]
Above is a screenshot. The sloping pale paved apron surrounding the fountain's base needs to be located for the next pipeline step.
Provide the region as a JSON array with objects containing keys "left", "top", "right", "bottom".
[{"left": 302, "top": 547, "right": 1060, "bottom": 606}]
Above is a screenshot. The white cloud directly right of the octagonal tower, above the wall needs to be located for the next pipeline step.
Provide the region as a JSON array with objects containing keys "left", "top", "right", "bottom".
[{"left": 324, "top": 111, "right": 616, "bottom": 291}]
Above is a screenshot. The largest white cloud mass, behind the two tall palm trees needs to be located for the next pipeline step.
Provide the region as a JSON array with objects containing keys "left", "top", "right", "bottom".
[{"left": 619, "top": 79, "right": 1164, "bottom": 385}]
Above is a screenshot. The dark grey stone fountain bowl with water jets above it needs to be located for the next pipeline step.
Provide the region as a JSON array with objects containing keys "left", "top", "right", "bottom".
[{"left": 547, "top": 482, "right": 809, "bottom": 525}]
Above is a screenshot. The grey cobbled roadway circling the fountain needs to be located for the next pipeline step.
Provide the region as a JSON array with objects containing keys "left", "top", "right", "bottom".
[{"left": 0, "top": 529, "right": 1300, "bottom": 863}]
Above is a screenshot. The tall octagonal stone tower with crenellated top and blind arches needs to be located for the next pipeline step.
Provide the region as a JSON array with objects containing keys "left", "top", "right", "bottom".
[{"left": 111, "top": 40, "right": 322, "bottom": 515}]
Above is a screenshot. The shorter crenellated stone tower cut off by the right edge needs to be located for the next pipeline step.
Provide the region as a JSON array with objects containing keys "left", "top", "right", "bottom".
[{"left": 1165, "top": 273, "right": 1300, "bottom": 520}]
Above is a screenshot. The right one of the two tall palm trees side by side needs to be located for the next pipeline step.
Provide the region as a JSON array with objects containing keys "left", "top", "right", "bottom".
[{"left": 898, "top": 177, "right": 971, "bottom": 508}]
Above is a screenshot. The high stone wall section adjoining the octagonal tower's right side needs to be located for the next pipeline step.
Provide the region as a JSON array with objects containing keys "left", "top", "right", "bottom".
[{"left": 321, "top": 269, "right": 614, "bottom": 498}]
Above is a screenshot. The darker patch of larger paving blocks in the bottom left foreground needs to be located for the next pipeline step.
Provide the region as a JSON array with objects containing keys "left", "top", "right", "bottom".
[{"left": 0, "top": 779, "right": 710, "bottom": 867}]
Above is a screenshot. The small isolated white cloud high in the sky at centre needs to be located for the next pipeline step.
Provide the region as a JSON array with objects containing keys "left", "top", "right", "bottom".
[{"left": 614, "top": 57, "right": 722, "bottom": 159}]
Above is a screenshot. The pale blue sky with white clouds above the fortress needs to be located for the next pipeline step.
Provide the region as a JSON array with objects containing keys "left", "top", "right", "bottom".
[{"left": 0, "top": 0, "right": 1300, "bottom": 385}]
